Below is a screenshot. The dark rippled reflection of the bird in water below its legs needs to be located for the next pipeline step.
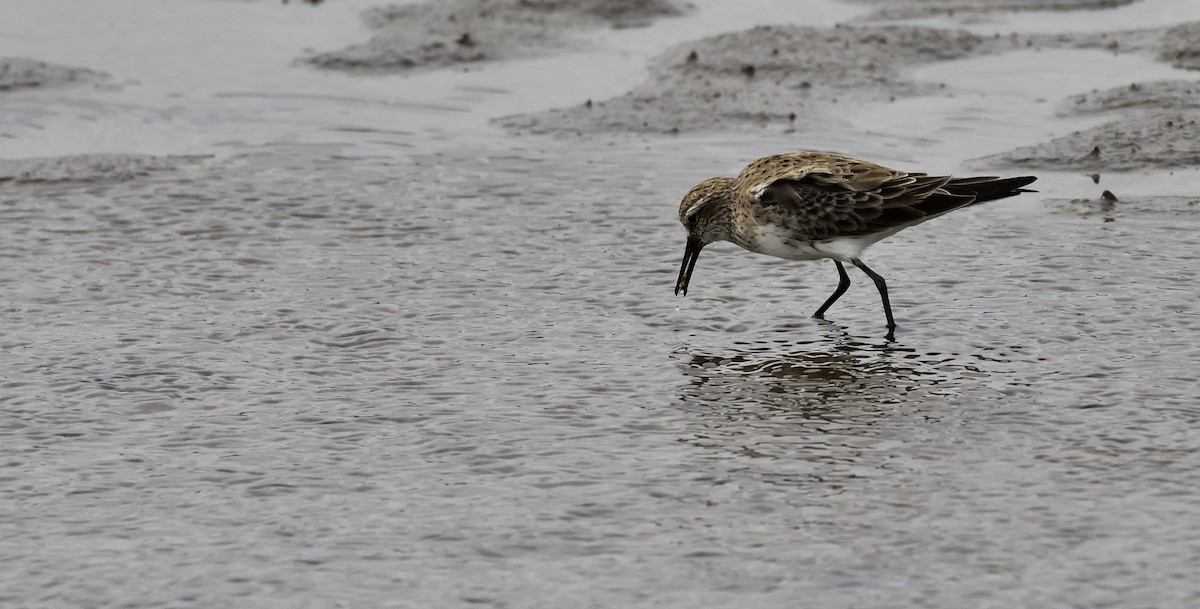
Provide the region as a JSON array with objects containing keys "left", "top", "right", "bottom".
[{"left": 678, "top": 324, "right": 977, "bottom": 486}]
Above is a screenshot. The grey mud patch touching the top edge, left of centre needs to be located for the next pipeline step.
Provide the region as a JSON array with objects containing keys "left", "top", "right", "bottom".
[{"left": 305, "top": 0, "right": 686, "bottom": 71}]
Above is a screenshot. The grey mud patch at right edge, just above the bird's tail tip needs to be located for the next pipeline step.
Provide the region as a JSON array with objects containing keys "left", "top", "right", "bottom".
[{"left": 977, "top": 110, "right": 1200, "bottom": 171}]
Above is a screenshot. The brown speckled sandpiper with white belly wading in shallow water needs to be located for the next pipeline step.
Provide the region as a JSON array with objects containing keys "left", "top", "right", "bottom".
[{"left": 676, "top": 152, "right": 1037, "bottom": 338}]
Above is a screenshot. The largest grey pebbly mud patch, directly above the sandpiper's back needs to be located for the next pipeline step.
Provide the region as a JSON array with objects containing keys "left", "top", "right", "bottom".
[{"left": 496, "top": 25, "right": 993, "bottom": 133}]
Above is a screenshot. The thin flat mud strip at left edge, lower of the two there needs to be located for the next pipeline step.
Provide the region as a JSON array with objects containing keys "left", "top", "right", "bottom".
[{"left": 0, "top": 155, "right": 211, "bottom": 183}]
